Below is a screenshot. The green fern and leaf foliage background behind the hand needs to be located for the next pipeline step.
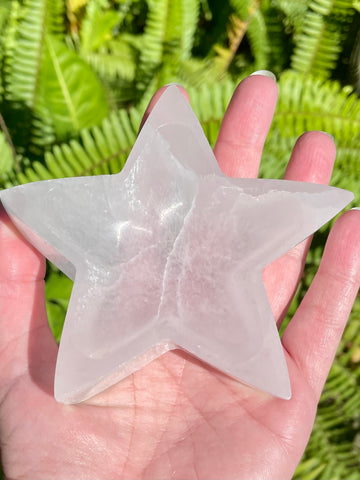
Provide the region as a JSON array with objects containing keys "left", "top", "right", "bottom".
[{"left": 0, "top": 0, "right": 360, "bottom": 480}]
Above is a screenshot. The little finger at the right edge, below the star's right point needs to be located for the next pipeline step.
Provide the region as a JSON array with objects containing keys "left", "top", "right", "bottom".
[{"left": 282, "top": 211, "right": 360, "bottom": 399}]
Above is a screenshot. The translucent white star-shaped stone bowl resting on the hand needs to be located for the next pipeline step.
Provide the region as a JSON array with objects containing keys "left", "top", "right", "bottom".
[{"left": 0, "top": 86, "right": 353, "bottom": 403}]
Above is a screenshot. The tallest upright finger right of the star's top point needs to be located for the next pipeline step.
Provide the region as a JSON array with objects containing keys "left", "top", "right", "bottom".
[{"left": 214, "top": 75, "right": 277, "bottom": 178}]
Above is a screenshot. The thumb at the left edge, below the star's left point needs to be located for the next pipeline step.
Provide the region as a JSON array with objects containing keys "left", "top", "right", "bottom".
[{"left": 0, "top": 207, "right": 56, "bottom": 395}]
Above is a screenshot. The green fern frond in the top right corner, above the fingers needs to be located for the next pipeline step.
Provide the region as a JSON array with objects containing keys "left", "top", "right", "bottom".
[{"left": 292, "top": 0, "right": 355, "bottom": 78}]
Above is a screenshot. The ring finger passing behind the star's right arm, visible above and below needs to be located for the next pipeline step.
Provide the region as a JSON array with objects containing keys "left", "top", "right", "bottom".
[{"left": 263, "top": 132, "right": 336, "bottom": 326}]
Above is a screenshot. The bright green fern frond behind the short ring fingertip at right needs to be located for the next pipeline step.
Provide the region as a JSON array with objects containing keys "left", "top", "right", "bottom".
[{"left": 261, "top": 71, "right": 360, "bottom": 198}]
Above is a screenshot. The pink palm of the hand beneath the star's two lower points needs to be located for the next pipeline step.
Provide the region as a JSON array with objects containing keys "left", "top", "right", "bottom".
[{"left": 2, "top": 338, "right": 315, "bottom": 479}]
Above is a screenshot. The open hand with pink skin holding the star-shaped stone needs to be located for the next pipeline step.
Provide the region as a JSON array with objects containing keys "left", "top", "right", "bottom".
[{"left": 0, "top": 76, "right": 360, "bottom": 480}]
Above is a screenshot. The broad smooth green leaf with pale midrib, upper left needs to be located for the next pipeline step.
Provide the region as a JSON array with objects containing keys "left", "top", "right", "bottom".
[{"left": 39, "top": 36, "right": 107, "bottom": 139}]
